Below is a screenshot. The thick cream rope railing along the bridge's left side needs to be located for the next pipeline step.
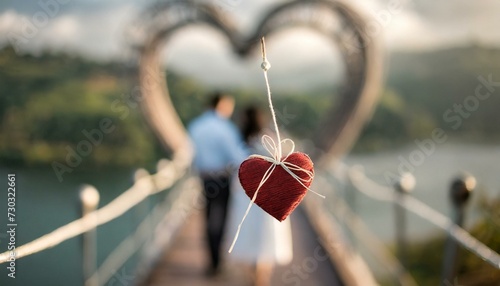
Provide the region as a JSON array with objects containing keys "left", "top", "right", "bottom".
[{"left": 0, "top": 152, "right": 190, "bottom": 264}]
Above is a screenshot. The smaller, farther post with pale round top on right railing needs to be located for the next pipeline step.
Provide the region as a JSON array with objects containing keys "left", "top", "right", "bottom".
[{"left": 394, "top": 173, "right": 415, "bottom": 276}]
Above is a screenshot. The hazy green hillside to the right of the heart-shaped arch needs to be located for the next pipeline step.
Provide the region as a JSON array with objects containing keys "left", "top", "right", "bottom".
[{"left": 356, "top": 46, "right": 500, "bottom": 150}]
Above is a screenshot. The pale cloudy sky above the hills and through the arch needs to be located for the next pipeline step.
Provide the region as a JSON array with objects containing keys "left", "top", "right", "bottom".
[{"left": 0, "top": 0, "right": 500, "bottom": 89}]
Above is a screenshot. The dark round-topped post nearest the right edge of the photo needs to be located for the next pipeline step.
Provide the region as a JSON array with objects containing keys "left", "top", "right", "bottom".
[{"left": 441, "top": 174, "right": 476, "bottom": 286}]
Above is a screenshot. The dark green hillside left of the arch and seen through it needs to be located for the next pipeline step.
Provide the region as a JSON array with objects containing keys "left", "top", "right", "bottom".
[{"left": 0, "top": 47, "right": 330, "bottom": 166}]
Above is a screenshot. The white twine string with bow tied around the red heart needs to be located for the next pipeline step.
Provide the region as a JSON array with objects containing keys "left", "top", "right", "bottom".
[{"left": 228, "top": 37, "right": 325, "bottom": 253}]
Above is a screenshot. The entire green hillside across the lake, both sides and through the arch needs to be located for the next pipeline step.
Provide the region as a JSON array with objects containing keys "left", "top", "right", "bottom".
[{"left": 0, "top": 44, "right": 500, "bottom": 166}]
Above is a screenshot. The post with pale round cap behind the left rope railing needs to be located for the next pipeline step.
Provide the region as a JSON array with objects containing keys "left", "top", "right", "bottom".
[{"left": 79, "top": 185, "right": 100, "bottom": 286}]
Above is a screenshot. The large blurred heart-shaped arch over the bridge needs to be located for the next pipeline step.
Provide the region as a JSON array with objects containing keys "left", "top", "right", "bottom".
[{"left": 132, "top": 0, "right": 382, "bottom": 166}]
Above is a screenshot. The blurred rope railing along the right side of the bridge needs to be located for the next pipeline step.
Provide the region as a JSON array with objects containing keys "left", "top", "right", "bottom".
[{"left": 328, "top": 163, "right": 500, "bottom": 269}]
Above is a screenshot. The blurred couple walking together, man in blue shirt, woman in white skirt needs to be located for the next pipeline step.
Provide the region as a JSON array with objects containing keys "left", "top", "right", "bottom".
[{"left": 188, "top": 93, "right": 292, "bottom": 286}]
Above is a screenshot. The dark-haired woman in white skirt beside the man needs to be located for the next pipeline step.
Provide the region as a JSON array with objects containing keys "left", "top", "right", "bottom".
[{"left": 226, "top": 107, "right": 293, "bottom": 286}]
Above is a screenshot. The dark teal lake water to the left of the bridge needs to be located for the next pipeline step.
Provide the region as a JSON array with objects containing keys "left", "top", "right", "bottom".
[{"left": 0, "top": 166, "right": 150, "bottom": 286}]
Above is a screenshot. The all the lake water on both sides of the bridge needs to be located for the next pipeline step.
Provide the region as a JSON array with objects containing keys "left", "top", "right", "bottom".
[{"left": 0, "top": 144, "right": 500, "bottom": 286}]
